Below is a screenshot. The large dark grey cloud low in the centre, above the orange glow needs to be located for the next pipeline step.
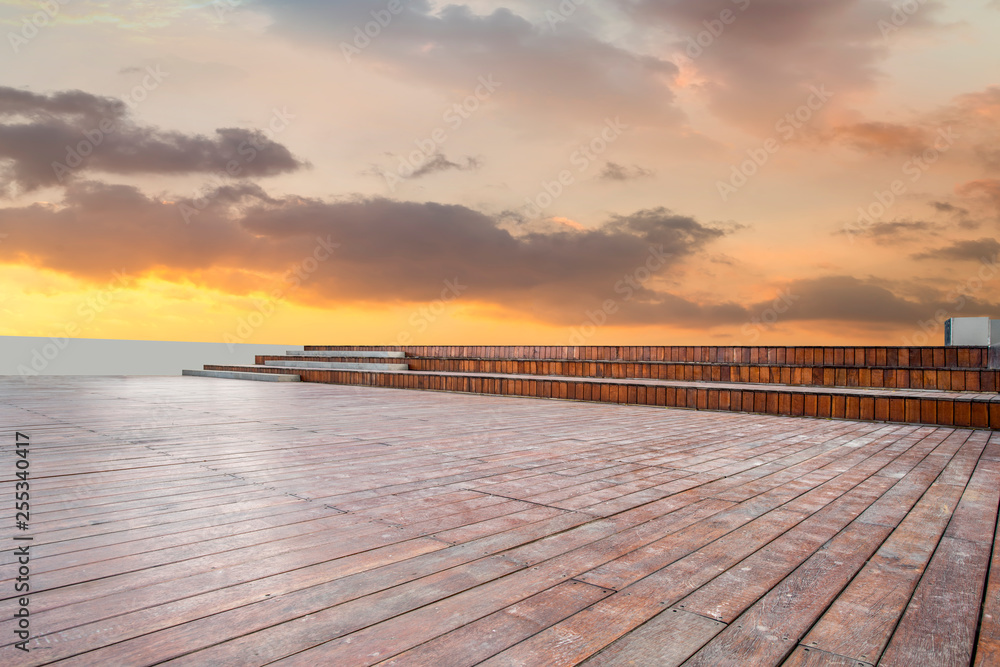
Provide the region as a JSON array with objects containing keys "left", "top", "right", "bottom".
[{"left": 235, "top": 199, "right": 726, "bottom": 313}]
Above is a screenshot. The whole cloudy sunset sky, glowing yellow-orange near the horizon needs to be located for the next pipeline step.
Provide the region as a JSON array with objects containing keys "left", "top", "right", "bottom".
[{"left": 0, "top": 0, "right": 1000, "bottom": 345}]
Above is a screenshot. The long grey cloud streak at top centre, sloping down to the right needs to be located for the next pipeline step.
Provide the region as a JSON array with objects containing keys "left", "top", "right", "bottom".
[{"left": 258, "top": 0, "right": 682, "bottom": 125}]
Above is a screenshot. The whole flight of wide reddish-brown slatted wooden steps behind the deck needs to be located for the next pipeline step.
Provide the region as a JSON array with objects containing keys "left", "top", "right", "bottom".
[{"left": 191, "top": 346, "right": 1000, "bottom": 429}]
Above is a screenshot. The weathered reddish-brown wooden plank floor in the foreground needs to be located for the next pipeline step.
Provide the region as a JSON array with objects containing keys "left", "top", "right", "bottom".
[{"left": 0, "top": 377, "right": 1000, "bottom": 667}]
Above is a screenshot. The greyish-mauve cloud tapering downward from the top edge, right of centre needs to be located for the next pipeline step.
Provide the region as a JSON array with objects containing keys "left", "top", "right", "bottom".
[{"left": 617, "top": 0, "right": 942, "bottom": 133}]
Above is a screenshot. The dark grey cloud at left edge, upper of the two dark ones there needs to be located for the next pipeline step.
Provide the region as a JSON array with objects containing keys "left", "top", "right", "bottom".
[{"left": 0, "top": 87, "right": 306, "bottom": 191}]
